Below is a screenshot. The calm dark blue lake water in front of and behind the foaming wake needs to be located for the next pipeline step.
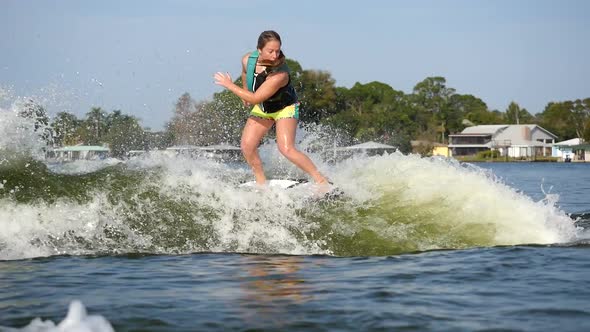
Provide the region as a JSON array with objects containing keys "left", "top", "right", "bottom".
[{"left": 0, "top": 163, "right": 590, "bottom": 331}]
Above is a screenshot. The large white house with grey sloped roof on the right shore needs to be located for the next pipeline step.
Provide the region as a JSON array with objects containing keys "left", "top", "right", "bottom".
[{"left": 449, "top": 124, "right": 557, "bottom": 158}]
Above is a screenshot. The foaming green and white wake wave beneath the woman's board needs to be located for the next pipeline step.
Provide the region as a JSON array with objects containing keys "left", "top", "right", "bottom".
[{"left": 0, "top": 120, "right": 580, "bottom": 259}]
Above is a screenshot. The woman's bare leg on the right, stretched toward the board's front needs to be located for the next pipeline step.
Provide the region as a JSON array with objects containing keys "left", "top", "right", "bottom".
[{"left": 276, "top": 118, "right": 328, "bottom": 184}]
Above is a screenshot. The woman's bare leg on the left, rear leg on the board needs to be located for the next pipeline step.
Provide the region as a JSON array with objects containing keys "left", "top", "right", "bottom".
[{"left": 240, "top": 117, "right": 274, "bottom": 184}]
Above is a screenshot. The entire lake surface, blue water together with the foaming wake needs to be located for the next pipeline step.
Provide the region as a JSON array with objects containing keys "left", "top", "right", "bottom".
[{"left": 0, "top": 110, "right": 590, "bottom": 331}]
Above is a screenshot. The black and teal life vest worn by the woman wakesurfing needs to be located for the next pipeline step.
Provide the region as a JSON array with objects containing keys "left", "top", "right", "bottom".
[{"left": 246, "top": 50, "right": 297, "bottom": 113}]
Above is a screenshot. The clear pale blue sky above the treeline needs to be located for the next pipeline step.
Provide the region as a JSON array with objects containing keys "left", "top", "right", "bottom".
[{"left": 0, "top": 0, "right": 590, "bottom": 130}]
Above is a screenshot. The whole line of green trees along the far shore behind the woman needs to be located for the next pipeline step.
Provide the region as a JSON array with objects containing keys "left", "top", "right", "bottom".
[{"left": 46, "top": 59, "right": 590, "bottom": 153}]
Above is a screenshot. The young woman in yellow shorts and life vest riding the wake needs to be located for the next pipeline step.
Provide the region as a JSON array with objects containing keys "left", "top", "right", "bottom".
[{"left": 215, "top": 31, "right": 328, "bottom": 185}]
